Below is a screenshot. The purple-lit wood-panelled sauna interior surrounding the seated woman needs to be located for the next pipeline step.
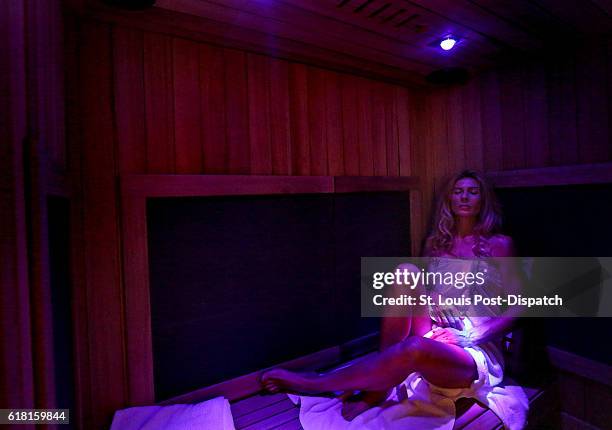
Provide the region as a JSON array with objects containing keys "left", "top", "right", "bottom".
[{"left": 0, "top": 0, "right": 612, "bottom": 430}]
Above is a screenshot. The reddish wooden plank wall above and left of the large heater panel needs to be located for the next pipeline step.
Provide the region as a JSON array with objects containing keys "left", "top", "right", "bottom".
[{"left": 66, "top": 16, "right": 418, "bottom": 428}]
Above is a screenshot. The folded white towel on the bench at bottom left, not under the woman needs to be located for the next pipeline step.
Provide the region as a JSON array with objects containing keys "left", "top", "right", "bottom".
[{"left": 111, "top": 397, "right": 235, "bottom": 430}]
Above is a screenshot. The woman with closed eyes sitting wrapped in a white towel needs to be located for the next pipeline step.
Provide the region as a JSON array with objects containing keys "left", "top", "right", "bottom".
[{"left": 261, "top": 170, "right": 520, "bottom": 420}]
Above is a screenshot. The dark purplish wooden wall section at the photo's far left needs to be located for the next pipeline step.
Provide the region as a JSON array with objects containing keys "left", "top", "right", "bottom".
[{"left": 0, "top": 0, "right": 67, "bottom": 428}]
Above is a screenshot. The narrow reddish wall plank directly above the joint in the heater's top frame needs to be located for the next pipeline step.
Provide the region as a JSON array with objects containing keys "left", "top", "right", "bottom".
[{"left": 325, "top": 72, "right": 344, "bottom": 176}]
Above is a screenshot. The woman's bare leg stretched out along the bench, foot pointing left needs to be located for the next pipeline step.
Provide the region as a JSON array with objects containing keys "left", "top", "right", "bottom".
[{"left": 262, "top": 336, "right": 476, "bottom": 393}]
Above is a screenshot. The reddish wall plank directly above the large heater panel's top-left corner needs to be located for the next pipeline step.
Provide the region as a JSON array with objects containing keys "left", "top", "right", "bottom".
[{"left": 144, "top": 33, "right": 175, "bottom": 173}]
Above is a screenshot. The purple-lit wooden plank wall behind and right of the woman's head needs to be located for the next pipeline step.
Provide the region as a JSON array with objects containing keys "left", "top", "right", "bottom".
[{"left": 419, "top": 40, "right": 612, "bottom": 218}]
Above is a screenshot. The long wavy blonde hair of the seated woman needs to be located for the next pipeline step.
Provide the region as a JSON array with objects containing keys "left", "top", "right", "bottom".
[{"left": 424, "top": 169, "right": 502, "bottom": 257}]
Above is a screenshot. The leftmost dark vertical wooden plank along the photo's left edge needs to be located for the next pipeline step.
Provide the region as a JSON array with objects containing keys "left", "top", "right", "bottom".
[{"left": 0, "top": 2, "right": 35, "bottom": 416}]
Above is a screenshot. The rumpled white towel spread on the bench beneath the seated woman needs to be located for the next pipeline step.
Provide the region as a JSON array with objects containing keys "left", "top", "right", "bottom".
[{"left": 289, "top": 345, "right": 529, "bottom": 430}]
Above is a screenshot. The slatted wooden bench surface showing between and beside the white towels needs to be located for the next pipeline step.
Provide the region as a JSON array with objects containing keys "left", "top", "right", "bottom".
[{"left": 231, "top": 381, "right": 542, "bottom": 430}]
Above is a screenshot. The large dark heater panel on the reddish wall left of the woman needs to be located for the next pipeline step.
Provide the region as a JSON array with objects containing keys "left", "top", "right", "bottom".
[{"left": 147, "top": 192, "right": 410, "bottom": 400}]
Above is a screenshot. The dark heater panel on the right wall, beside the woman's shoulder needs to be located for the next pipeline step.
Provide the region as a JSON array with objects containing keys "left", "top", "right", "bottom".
[{"left": 497, "top": 184, "right": 612, "bottom": 364}]
